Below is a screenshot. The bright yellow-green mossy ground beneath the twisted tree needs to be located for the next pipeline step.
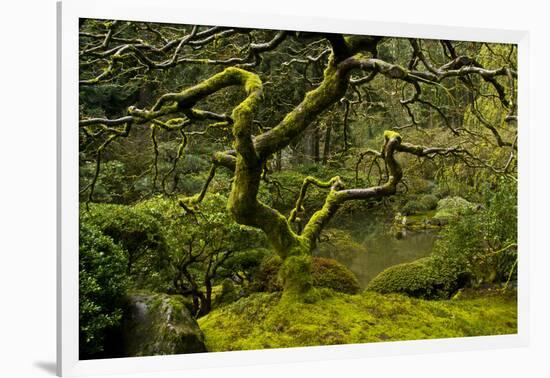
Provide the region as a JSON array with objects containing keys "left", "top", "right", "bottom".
[{"left": 199, "top": 289, "right": 517, "bottom": 351}]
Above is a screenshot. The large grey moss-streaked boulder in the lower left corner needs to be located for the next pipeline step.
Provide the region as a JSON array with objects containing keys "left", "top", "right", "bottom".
[{"left": 122, "top": 292, "right": 207, "bottom": 357}]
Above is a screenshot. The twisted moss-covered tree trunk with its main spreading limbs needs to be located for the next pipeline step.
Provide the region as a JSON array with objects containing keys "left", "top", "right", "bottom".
[{"left": 103, "top": 34, "right": 496, "bottom": 298}]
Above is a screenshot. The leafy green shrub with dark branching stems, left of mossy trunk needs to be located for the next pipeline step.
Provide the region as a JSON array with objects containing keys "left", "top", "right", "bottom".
[{"left": 136, "top": 193, "right": 266, "bottom": 316}]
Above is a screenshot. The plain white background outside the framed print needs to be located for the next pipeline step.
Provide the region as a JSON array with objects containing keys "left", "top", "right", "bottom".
[{"left": 0, "top": 0, "right": 550, "bottom": 378}]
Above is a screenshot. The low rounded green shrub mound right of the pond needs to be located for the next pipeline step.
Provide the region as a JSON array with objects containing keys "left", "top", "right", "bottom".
[{"left": 366, "top": 257, "right": 467, "bottom": 299}]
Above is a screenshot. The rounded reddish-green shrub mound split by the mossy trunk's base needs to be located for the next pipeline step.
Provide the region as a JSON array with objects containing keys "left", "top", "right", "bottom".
[{"left": 252, "top": 255, "right": 360, "bottom": 294}]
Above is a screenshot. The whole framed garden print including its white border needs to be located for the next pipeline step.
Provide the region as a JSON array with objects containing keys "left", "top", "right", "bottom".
[{"left": 58, "top": 1, "right": 528, "bottom": 376}]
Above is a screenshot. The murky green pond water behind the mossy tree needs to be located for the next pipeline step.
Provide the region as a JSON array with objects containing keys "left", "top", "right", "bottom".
[{"left": 315, "top": 220, "right": 437, "bottom": 288}]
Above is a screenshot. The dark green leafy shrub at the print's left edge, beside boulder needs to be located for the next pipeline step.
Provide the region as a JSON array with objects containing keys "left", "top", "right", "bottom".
[{"left": 79, "top": 223, "right": 129, "bottom": 359}]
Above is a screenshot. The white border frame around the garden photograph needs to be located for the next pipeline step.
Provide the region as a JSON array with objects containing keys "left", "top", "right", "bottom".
[{"left": 57, "top": 0, "right": 529, "bottom": 376}]
